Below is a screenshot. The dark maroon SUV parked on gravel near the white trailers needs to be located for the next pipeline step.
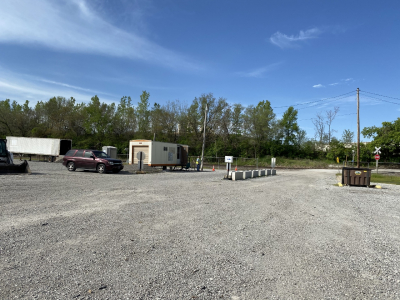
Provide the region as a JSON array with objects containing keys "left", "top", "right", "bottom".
[{"left": 63, "top": 149, "right": 124, "bottom": 173}]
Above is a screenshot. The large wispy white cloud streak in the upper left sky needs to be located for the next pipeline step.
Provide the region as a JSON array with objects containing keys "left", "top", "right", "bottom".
[{"left": 0, "top": 0, "right": 202, "bottom": 69}]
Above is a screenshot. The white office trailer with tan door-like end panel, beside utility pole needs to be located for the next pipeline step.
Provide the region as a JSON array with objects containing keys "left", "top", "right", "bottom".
[{"left": 129, "top": 140, "right": 189, "bottom": 167}]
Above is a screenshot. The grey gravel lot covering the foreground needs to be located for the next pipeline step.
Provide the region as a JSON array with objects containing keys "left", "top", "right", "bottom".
[{"left": 0, "top": 162, "right": 400, "bottom": 300}]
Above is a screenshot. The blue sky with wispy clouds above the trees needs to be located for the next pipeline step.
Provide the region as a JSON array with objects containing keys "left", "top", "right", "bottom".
[{"left": 0, "top": 0, "right": 400, "bottom": 140}]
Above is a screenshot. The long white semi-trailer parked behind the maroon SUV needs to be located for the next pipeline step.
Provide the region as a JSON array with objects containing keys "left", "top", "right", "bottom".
[{"left": 6, "top": 136, "right": 72, "bottom": 161}]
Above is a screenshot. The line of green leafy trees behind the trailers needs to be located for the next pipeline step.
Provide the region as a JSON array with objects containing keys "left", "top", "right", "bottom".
[{"left": 0, "top": 91, "right": 398, "bottom": 159}]
